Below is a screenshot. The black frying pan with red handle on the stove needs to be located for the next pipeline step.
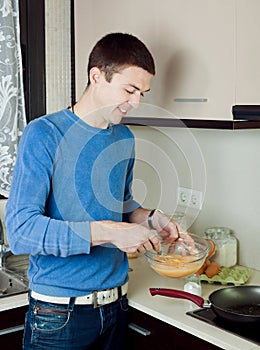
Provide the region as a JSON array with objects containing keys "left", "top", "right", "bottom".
[{"left": 150, "top": 286, "right": 260, "bottom": 325}]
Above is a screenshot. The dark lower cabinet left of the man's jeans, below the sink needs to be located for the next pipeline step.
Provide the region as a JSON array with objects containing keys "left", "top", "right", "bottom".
[{"left": 0, "top": 306, "right": 28, "bottom": 350}]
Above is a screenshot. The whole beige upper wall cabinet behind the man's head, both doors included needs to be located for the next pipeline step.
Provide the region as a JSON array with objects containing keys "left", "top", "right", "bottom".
[{"left": 75, "top": 0, "right": 260, "bottom": 121}]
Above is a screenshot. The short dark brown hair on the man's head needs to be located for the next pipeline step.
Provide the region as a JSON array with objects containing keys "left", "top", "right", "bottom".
[{"left": 88, "top": 33, "right": 155, "bottom": 85}]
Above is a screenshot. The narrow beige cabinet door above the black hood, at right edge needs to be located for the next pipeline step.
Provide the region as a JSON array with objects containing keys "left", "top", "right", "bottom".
[{"left": 235, "top": 0, "right": 260, "bottom": 105}]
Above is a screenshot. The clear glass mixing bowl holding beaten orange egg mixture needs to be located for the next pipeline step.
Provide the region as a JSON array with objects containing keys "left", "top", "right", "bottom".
[{"left": 145, "top": 233, "right": 210, "bottom": 278}]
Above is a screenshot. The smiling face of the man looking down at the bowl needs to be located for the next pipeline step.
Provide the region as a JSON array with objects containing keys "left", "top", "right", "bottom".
[{"left": 92, "top": 66, "right": 153, "bottom": 124}]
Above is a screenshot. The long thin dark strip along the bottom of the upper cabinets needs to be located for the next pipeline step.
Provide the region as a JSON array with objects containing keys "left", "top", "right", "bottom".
[{"left": 122, "top": 117, "right": 260, "bottom": 130}]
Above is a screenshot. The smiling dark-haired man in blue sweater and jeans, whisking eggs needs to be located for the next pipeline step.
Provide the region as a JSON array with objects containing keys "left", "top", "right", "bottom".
[{"left": 5, "top": 33, "right": 185, "bottom": 350}]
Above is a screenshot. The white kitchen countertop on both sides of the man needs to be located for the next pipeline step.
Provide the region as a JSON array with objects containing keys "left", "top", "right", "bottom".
[{"left": 0, "top": 257, "right": 260, "bottom": 350}]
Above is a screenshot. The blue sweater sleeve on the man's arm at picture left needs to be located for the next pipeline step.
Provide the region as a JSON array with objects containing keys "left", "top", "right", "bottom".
[{"left": 5, "top": 121, "right": 91, "bottom": 257}]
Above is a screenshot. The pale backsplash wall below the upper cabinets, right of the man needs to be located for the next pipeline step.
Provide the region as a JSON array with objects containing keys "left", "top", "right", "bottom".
[{"left": 132, "top": 127, "right": 260, "bottom": 269}]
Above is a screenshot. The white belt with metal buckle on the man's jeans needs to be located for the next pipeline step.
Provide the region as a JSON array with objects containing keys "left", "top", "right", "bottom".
[{"left": 31, "top": 283, "right": 128, "bottom": 307}]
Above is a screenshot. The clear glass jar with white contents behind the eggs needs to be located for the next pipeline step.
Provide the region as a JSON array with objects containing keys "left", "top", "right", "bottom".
[{"left": 205, "top": 227, "right": 237, "bottom": 267}]
